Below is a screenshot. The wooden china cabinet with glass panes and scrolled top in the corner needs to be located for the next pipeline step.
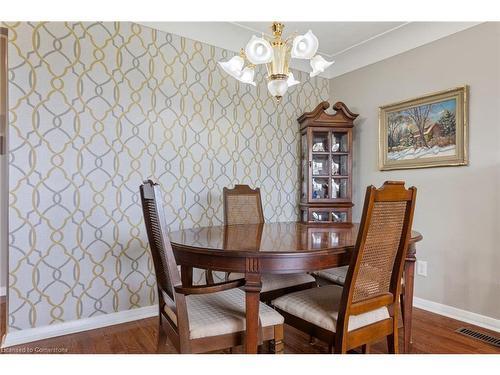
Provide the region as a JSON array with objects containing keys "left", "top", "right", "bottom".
[{"left": 298, "top": 102, "right": 358, "bottom": 224}]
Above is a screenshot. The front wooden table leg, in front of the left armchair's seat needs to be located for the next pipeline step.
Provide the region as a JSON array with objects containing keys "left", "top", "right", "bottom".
[{"left": 245, "top": 273, "right": 262, "bottom": 354}]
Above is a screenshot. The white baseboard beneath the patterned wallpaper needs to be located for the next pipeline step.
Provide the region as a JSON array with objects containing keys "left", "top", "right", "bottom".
[{"left": 0, "top": 305, "right": 158, "bottom": 348}]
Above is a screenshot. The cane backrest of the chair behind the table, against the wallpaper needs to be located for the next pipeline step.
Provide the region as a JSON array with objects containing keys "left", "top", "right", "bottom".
[{"left": 223, "top": 185, "right": 264, "bottom": 225}]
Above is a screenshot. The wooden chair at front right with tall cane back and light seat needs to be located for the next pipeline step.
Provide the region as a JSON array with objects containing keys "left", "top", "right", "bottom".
[{"left": 272, "top": 181, "right": 417, "bottom": 353}]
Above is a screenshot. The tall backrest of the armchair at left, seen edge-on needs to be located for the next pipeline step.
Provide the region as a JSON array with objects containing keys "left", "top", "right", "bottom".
[{"left": 140, "top": 180, "right": 185, "bottom": 312}]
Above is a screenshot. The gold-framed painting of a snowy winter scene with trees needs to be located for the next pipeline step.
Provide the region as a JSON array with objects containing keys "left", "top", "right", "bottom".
[{"left": 379, "top": 86, "right": 468, "bottom": 171}]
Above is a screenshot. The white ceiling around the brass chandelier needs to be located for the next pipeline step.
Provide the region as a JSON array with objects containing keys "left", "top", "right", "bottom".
[{"left": 139, "top": 21, "right": 480, "bottom": 78}]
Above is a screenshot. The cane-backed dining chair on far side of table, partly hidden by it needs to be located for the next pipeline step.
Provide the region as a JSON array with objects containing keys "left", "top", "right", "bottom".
[{"left": 220, "top": 185, "right": 317, "bottom": 302}]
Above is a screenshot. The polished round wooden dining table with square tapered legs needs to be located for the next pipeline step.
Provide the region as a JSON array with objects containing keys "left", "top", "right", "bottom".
[{"left": 169, "top": 222, "right": 422, "bottom": 353}]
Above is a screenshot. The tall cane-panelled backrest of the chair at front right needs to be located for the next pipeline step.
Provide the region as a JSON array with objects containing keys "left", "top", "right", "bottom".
[{"left": 339, "top": 181, "right": 417, "bottom": 320}]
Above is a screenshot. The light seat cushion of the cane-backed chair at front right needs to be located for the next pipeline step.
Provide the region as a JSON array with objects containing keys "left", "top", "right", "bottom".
[{"left": 272, "top": 285, "right": 390, "bottom": 332}]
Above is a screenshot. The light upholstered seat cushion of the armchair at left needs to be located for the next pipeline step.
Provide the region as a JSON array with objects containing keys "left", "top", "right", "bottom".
[{"left": 186, "top": 289, "right": 284, "bottom": 339}]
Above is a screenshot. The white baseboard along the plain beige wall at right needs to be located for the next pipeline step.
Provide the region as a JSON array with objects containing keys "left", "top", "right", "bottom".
[{"left": 413, "top": 297, "right": 500, "bottom": 332}]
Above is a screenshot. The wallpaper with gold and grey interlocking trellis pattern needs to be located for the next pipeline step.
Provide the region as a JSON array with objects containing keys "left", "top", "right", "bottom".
[{"left": 5, "top": 22, "right": 328, "bottom": 330}]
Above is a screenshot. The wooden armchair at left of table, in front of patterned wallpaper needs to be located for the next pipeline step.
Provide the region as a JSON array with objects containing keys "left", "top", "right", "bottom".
[{"left": 140, "top": 180, "right": 284, "bottom": 354}]
